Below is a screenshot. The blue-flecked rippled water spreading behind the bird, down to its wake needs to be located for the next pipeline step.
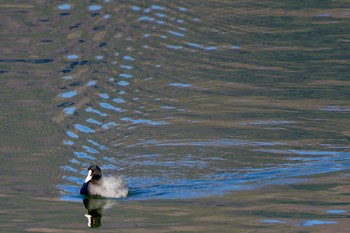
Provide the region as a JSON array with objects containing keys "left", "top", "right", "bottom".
[{"left": 53, "top": 2, "right": 349, "bottom": 199}]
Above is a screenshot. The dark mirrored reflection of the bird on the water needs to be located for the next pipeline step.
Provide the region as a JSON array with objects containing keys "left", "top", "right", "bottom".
[{"left": 83, "top": 197, "right": 116, "bottom": 228}]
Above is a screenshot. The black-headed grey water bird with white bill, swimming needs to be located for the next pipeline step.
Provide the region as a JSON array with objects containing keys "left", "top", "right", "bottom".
[{"left": 80, "top": 165, "right": 129, "bottom": 198}]
